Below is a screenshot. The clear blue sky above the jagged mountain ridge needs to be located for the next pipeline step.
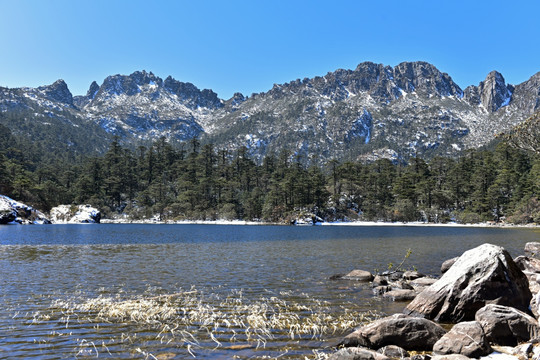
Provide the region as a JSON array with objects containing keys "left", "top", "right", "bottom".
[{"left": 0, "top": 0, "right": 540, "bottom": 98}]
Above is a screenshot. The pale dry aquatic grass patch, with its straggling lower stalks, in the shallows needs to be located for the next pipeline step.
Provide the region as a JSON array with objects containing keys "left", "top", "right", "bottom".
[{"left": 28, "top": 288, "right": 378, "bottom": 359}]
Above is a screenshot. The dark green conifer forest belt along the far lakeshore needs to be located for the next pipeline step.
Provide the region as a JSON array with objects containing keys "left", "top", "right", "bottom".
[{"left": 0, "top": 127, "right": 540, "bottom": 223}]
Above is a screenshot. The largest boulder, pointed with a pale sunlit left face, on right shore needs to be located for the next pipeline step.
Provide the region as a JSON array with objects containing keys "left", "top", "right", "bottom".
[{"left": 404, "top": 244, "right": 532, "bottom": 323}]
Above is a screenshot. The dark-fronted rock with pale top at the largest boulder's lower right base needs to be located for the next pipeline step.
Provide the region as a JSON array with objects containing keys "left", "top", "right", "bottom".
[{"left": 476, "top": 304, "right": 540, "bottom": 346}]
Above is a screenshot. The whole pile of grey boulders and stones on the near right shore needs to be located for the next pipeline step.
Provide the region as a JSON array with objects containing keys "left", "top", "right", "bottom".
[{"left": 329, "top": 243, "right": 540, "bottom": 360}]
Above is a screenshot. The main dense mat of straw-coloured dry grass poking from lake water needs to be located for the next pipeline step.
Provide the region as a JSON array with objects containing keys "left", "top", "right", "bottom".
[{"left": 45, "top": 289, "right": 376, "bottom": 359}]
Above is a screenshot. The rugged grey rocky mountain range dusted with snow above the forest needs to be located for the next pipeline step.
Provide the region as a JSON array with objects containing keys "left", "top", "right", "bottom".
[{"left": 0, "top": 62, "right": 540, "bottom": 162}]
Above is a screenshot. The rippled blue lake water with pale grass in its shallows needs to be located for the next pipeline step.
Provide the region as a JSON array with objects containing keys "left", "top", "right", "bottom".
[{"left": 0, "top": 224, "right": 540, "bottom": 359}]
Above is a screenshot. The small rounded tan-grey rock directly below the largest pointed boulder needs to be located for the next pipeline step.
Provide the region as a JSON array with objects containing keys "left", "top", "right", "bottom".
[{"left": 433, "top": 321, "right": 491, "bottom": 358}]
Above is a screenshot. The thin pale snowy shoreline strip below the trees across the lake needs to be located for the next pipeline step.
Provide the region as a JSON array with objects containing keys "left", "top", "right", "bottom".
[{"left": 101, "top": 219, "right": 540, "bottom": 229}]
